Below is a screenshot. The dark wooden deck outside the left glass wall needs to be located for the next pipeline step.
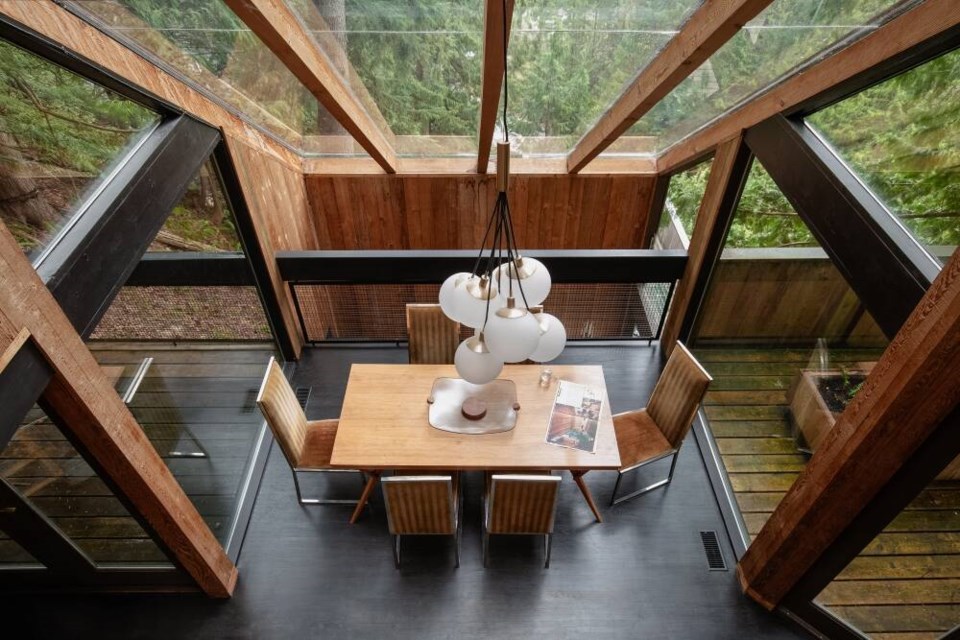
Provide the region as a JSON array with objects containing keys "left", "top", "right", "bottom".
[{"left": 0, "top": 342, "right": 273, "bottom": 565}]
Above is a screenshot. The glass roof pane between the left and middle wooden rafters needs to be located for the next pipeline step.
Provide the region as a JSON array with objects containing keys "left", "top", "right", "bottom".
[{"left": 287, "top": 0, "right": 483, "bottom": 156}]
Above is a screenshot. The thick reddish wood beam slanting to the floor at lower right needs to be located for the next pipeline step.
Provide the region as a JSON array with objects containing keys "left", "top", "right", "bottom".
[{"left": 738, "top": 246, "right": 960, "bottom": 608}]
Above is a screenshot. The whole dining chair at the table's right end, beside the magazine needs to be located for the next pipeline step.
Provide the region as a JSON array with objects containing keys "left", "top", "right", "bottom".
[{"left": 610, "top": 342, "right": 713, "bottom": 505}]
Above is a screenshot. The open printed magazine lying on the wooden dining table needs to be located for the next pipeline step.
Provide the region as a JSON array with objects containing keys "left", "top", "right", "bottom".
[{"left": 547, "top": 380, "right": 603, "bottom": 453}]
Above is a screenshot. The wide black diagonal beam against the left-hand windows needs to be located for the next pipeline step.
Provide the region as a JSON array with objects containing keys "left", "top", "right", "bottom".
[{"left": 36, "top": 116, "right": 220, "bottom": 338}]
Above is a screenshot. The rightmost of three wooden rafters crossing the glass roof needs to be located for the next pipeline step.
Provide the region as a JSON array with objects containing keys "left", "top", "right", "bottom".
[{"left": 567, "top": 0, "right": 773, "bottom": 173}]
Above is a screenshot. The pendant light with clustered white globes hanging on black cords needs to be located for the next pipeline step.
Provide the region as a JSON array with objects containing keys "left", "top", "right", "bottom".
[{"left": 440, "top": 7, "right": 567, "bottom": 384}]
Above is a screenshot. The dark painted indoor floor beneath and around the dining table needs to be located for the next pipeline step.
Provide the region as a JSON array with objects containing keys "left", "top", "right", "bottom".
[{"left": 0, "top": 347, "right": 807, "bottom": 640}]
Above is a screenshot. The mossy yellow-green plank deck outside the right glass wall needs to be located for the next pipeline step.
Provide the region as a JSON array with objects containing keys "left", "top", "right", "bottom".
[{"left": 696, "top": 348, "right": 960, "bottom": 640}]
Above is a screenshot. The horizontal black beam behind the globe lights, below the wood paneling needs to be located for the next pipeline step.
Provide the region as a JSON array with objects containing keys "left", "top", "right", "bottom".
[{"left": 277, "top": 249, "right": 687, "bottom": 284}]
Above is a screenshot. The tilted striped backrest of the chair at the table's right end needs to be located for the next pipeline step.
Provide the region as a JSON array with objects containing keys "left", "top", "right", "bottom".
[{"left": 647, "top": 342, "right": 713, "bottom": 448}]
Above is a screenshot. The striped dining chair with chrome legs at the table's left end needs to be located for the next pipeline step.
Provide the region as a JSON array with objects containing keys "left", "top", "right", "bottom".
[{"left": 257, "top": 358, "right": 359, "bottom": 505}]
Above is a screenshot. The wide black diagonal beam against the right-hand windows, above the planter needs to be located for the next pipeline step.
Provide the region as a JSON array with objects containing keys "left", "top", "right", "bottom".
[{"left": 746, "top": 116, "right": 940, "bottom": 338}]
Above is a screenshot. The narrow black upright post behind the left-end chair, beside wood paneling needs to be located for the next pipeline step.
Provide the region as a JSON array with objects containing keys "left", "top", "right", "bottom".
[{"left": 213, "top": 141, "right": 299, "bottom": 360}]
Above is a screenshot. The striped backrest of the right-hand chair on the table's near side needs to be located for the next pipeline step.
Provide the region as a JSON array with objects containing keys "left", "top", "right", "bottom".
[{"left": 486, "top": 474, "right": 560, "bottom": 533}]
